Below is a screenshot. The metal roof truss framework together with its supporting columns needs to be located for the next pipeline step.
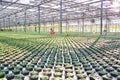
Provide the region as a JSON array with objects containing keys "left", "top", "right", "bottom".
[{"left": 0, "top": 0, "right": 120, "bottom": 33}]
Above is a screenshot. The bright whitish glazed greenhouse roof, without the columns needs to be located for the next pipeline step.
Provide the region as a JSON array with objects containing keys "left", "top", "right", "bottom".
[{"left": 0, "top": 0, "right": 120, "bottom": 22}]
